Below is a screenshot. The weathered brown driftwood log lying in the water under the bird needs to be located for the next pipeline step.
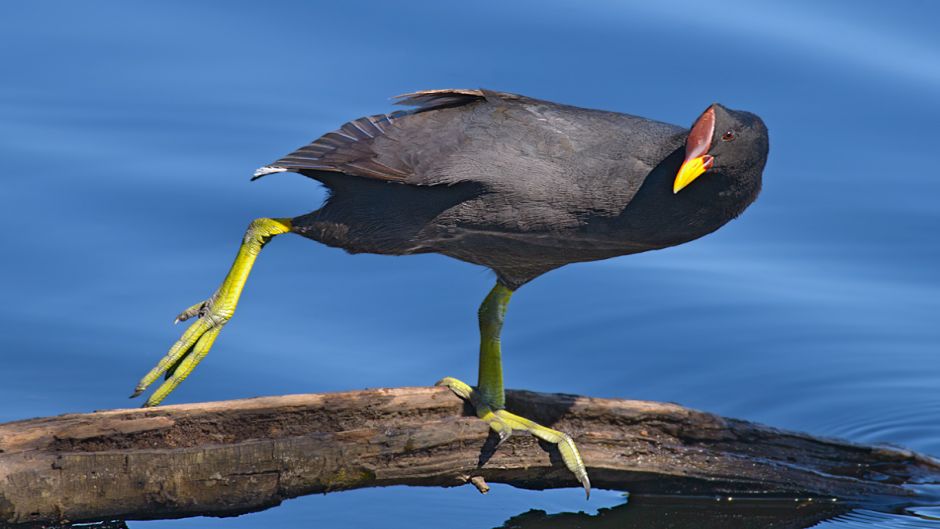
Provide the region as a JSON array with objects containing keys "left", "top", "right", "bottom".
[{"left": 0, "top": 388, "right": 940, "bottom": 523}]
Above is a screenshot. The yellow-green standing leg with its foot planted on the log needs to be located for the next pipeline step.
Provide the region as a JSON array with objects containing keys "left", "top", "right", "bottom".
[{"left": 437, "top": 283, "right": 591, "bottom": 497}]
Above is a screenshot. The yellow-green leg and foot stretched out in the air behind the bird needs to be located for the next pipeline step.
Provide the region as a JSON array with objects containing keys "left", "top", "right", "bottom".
[{"left": 131, "top": 219, "right": 291, "bottom": 406}]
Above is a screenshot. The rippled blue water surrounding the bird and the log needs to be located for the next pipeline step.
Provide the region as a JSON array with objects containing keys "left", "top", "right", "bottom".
[{"left": 0, "top": 1, "right": 940, "bottom": 529}]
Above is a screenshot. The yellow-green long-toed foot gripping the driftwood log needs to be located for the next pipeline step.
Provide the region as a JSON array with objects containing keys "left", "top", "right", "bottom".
[{"left": 435, "top": 377, "right": 591, "bottom": 498}]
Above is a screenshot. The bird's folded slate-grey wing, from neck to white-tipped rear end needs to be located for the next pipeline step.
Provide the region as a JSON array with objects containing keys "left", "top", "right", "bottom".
[{"left": 256, "top": 90, "right": 685, "bottom": 221}]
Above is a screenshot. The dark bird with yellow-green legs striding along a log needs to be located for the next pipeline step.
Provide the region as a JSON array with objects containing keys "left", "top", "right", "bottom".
[{"left": 132, "top": 89, "right": 769, "bottom": 497}]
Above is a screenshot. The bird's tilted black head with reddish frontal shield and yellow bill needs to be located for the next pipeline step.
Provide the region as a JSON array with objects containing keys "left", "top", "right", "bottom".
[{"left": 672, "top": 103, "right": 768, "bottom": 193}]
